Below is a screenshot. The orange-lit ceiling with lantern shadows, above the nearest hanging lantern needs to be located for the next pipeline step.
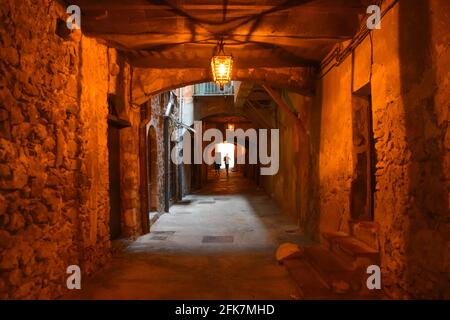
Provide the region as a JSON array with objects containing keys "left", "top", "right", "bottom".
[{"left": 71, "top": 0, "right": 367, "bottom": 68}]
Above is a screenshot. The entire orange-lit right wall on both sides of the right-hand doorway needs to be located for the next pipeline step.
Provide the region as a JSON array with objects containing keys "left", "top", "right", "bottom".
[{"left": 315, "top": 0, "right": 450, "bottom": 298}]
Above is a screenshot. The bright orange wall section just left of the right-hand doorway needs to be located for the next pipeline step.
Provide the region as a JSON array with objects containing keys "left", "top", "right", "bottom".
[{"left": 317, "top": 59, "right": 353, "bottom": 236}]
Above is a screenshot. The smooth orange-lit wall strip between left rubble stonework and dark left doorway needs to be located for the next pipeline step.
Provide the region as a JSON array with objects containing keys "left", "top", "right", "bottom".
[{"left": 77, "top": 37, "right": 109, "bottom": 273}]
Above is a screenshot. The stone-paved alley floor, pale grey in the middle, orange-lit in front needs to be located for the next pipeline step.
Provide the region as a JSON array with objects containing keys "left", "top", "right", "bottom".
[{"left": 66, "top": 173, "right": 310, "bottom": 299}]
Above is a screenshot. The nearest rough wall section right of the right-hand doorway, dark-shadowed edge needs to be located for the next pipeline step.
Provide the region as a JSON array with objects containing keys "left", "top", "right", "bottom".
[{"left": 373, "top": 0, "right": 450, "bottom": 299}]
